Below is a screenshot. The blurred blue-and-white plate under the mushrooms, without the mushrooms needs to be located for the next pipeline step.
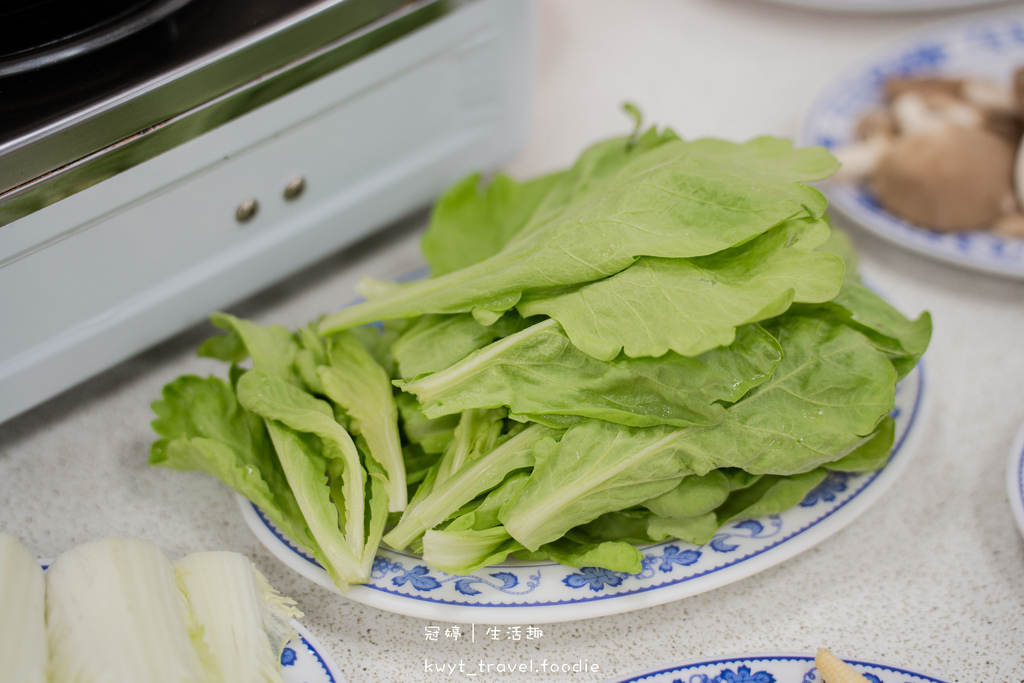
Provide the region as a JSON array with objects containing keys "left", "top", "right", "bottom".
[{"left": 801, "top": 8, "right": 1024, "bottom": 278}]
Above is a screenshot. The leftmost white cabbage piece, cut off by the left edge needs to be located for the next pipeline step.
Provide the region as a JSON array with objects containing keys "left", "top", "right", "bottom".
[{"left": 0, "top": 533, "right": 47, "bottom": 683}]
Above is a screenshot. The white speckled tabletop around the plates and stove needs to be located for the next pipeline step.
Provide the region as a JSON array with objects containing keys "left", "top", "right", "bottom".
[{"left": 0, "top": 0, "right": 1024, "bottom": 683}]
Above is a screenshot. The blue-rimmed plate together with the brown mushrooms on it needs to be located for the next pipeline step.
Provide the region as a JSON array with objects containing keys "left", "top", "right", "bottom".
[{"left": 801, "top": 7, "right": 1024, "bottom": 279}]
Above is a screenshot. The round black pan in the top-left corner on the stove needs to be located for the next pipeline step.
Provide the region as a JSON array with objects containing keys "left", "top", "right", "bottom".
[{"left": 0, "top": 0, "right": 189, "bottom": 76}]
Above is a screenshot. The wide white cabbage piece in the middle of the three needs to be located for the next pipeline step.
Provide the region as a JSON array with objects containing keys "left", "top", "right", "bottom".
[{"left": 46, "top": 538, "right": 207, "bottom": 683}]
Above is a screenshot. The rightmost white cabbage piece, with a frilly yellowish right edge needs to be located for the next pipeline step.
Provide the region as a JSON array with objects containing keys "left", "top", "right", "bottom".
[{"left": 174, "top": 552, "right": 302, "bottom": 683}]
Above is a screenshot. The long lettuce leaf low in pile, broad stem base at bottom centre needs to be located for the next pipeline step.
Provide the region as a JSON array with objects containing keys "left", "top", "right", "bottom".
[{"left": 491, "top": 315, "right": 896, "bottom": 550}]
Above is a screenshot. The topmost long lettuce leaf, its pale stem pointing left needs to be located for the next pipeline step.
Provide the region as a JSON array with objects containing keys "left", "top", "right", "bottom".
[{"left": 319, "top": 138, "right": 835, "bottom": 334}]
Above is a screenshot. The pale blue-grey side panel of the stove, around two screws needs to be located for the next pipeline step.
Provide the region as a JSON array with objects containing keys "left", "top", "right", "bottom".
[{"left": 0, "top": 0, "right": 535, "bottom": 421}]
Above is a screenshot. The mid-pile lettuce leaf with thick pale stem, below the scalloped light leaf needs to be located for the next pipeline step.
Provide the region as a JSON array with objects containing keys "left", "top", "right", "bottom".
[{"left": 396, "top": 319, "right": 781, "bottom": 427}]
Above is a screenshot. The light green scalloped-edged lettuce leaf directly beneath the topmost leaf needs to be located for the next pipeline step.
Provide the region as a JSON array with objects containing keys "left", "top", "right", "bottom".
[{"left": 518, "top": 218, "right": 844, "bottom": 360}]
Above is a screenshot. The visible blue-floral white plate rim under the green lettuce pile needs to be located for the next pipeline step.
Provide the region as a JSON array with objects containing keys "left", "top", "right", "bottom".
[{"left": 238, "top": 364, "right": 928, "bottom": 624}]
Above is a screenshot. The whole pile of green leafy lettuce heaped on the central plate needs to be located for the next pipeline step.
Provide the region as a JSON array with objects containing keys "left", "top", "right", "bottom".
[{"left": 152, "top": 109, "right": 932, "bottom": 587}]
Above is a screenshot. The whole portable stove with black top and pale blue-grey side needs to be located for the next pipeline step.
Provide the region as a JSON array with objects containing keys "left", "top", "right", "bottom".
[{"left": 0, "top": 0, "right": 535, "bottom": 421}]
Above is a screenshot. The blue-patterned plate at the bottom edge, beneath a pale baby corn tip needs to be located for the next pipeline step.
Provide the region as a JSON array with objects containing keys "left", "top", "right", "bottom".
[{"left": 606, "top": 653, "right": 945, "bottom": 683}]
